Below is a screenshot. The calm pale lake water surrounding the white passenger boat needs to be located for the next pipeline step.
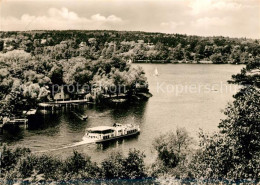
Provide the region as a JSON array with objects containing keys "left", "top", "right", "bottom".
[{"left": 2, "top": 64, "right": 243, "bottom": 162}]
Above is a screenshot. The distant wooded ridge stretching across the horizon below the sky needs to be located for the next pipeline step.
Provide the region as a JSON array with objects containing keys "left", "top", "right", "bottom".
[{"left": 0, "top": 30, "right": 260, "bottom": 64}]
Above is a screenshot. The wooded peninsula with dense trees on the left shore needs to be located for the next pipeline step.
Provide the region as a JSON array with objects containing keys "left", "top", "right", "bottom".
[{"left": 0, "top": 32, "right": 154, "bottom": 121}]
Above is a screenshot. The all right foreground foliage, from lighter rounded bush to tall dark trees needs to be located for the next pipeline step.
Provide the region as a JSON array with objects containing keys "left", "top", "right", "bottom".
[{"left": 154, "top": 60, "right": 260, "bottom": 184}]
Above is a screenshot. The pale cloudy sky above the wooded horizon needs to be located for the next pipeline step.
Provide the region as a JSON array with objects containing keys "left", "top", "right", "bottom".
[{"left": 0, "top": 0, "right": 260, "bottom": 39}]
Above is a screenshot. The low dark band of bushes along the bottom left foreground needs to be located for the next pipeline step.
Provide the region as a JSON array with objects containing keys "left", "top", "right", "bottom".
[{"left": 1, "top": 146, "right": 147, "bottom": 183}]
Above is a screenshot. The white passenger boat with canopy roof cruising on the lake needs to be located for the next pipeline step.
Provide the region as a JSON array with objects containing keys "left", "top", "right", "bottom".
[{"left": 83, "top": 123, "right": 140, "bottom": 143}]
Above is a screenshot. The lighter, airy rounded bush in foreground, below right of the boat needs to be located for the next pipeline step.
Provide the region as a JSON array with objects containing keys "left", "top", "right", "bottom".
[{"left": 150, "top": 128, "right": 194, "bottom": 180}]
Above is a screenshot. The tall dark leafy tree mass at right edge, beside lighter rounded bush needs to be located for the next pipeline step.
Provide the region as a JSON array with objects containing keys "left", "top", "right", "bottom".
[{"left": 192, "top": 61, "right": 260, "bottom": 182}]
